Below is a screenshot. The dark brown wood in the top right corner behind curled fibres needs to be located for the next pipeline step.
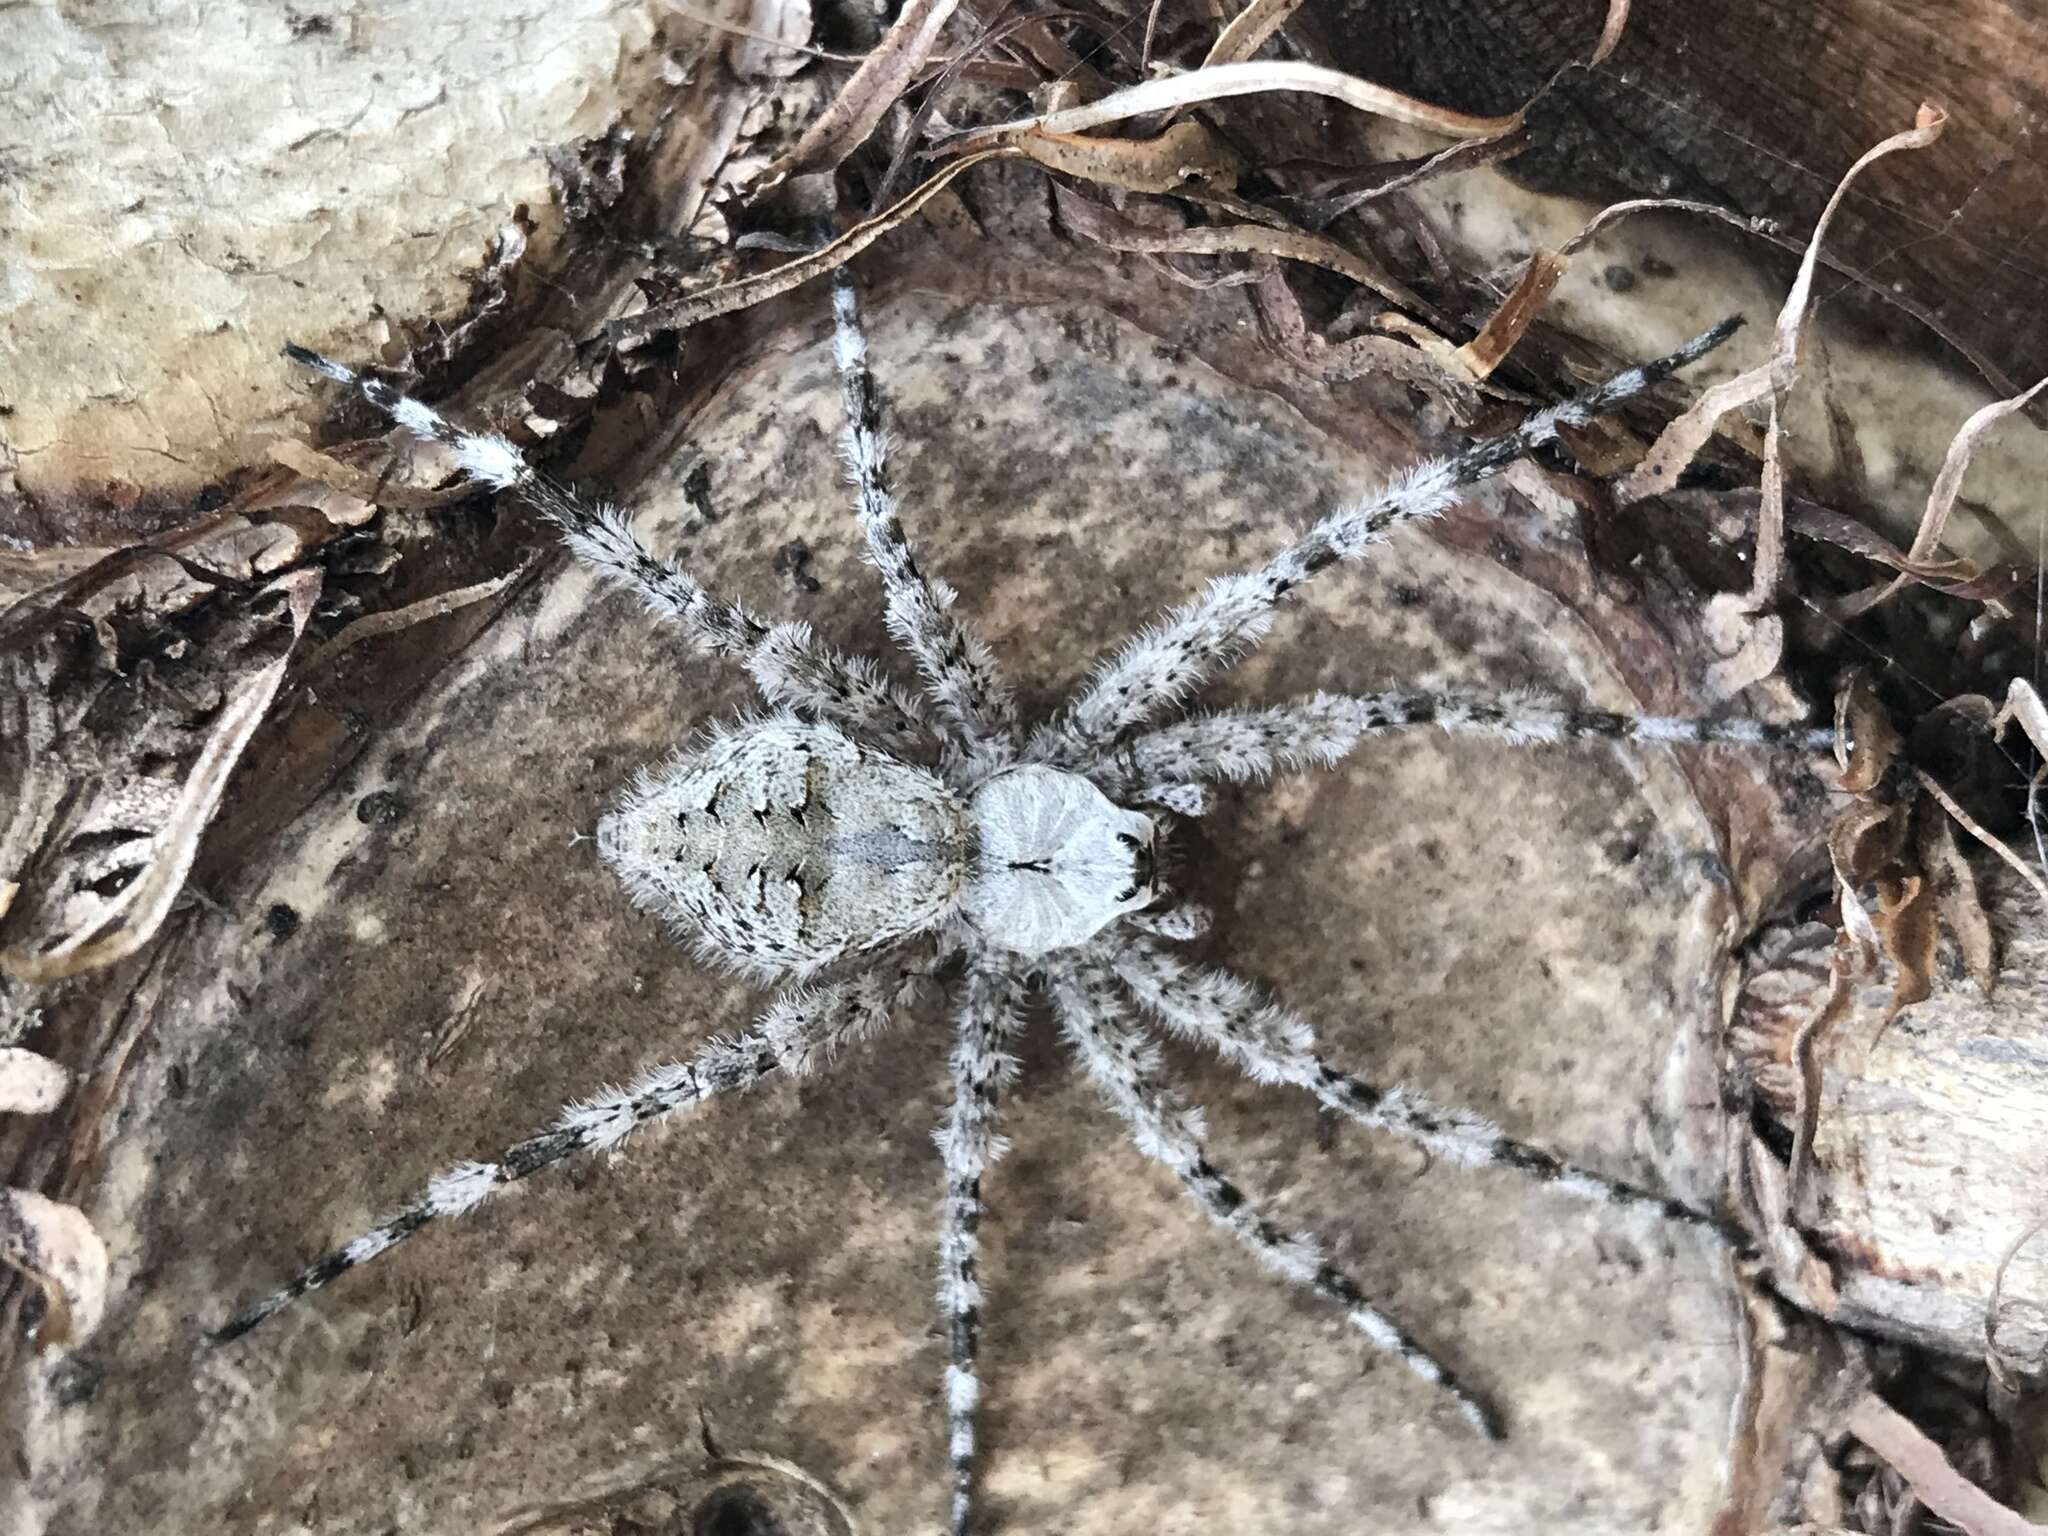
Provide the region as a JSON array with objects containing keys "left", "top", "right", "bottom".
[{"left": 1294, "top": 0, "right": 2048, "bottom": 397}]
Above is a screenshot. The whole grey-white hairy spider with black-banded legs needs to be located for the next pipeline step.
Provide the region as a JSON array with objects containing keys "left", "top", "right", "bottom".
[{"left": 211, "top": 272, "right": 1833, "bottom": 1536}]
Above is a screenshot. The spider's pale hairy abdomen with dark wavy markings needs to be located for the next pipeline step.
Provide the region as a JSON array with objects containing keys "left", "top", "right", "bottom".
[{"left": 598, "top": 717, "right": 973, "bottom": 973}]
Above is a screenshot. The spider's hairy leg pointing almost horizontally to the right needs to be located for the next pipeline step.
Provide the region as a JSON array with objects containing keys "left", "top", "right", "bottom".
[{"left": 1092, "top": 688, "right": 1835, "bottom": 797}]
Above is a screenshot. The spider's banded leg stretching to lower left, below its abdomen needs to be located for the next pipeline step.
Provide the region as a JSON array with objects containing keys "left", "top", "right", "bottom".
[{"left": 207, "top": 971, "right": 893, "bottom": 1343}]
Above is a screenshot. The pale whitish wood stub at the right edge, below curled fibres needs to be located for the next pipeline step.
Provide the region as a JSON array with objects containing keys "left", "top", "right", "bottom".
[{"left": 1729, "top": 870, "right": 2048, "bottom": 1374}]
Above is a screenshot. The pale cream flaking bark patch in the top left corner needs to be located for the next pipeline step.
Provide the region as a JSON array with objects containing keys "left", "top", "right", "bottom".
[{"left": 0, "top": 0, "right": 655, "bottom": 520}]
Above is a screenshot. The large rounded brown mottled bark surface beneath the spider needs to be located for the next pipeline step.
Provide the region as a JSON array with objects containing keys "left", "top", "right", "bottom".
[{"left": 16, "top": 297, "right": 1826, "bottom": 1534}]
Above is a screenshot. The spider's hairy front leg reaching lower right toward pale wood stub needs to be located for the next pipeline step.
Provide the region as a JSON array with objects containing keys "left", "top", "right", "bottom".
[{"left": 1104, "top": 940, "right": 1749, "bottom": 1249}]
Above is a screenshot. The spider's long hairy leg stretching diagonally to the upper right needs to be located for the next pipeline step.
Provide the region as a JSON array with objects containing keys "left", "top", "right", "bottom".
[{"left": 1026, "top": 319, "right": 1741, "bottom": 768}]
